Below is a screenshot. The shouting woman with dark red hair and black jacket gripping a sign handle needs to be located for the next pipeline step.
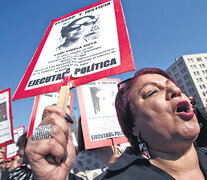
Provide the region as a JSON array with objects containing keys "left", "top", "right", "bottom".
[{"left": 26, "top": 68, "right": 207, "bottom": 180}]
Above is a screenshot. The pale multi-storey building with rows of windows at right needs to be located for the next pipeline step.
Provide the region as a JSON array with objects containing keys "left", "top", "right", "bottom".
[{"left": 166, "top": 53, "right": 207, "bottom": 115}]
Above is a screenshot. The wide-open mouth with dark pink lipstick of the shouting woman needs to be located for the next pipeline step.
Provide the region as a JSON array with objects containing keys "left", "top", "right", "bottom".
[{"left": 175, "top": 100, "right": 194, "bottom": 120}]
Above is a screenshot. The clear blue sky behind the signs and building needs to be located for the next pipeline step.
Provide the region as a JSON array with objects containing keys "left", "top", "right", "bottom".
[{"left": 0, "top": 0, "right": 207, "bottom": 130}]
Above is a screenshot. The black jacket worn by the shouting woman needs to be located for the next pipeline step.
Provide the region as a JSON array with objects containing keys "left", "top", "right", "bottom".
[{"left": 95, "top": 148, "right": 207, "bottom": 180}]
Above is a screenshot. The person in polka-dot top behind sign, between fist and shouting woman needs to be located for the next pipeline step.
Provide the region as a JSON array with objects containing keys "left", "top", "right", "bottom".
[{"left": 71, "top": 118, "right": 121, "bottom": 180}]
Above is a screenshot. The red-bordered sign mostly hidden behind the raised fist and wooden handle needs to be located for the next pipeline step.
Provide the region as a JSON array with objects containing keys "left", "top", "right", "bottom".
[{"left": 27, "top": 92, "right": 74, "bottom": 138}]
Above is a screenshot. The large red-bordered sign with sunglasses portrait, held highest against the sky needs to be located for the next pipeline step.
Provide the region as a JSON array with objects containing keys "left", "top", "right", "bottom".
[{"left": 13, "top": 0, "right": 135, "bottom": 100}]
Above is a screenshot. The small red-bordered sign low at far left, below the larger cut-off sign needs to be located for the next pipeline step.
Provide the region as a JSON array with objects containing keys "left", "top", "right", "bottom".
[{"left": 5, "top": 126, "right": 25, "bottom": 160}]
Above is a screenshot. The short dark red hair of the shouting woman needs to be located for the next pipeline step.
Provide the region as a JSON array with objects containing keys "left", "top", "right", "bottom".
[{"left": 115, "top": 68, "right": 178, "bottom": 151}]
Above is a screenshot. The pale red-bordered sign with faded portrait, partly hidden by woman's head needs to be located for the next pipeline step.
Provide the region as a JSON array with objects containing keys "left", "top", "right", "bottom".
[{"left": 76, "top": 78, "right": 128, "bottom": 149}]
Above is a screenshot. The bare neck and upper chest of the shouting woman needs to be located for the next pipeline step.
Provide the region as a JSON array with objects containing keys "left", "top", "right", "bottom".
[{"left": 150, "top": 144, "right": 204, "bottom": 179}]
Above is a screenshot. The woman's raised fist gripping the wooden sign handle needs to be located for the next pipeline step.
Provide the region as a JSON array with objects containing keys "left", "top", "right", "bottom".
[{"left": 26, "top": 106, "right": 75, "bottom": 180}]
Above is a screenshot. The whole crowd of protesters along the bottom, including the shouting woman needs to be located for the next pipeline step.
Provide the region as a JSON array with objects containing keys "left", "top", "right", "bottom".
[{"left": 0, "top": 68, "right": 207, "bottom": 180}]
